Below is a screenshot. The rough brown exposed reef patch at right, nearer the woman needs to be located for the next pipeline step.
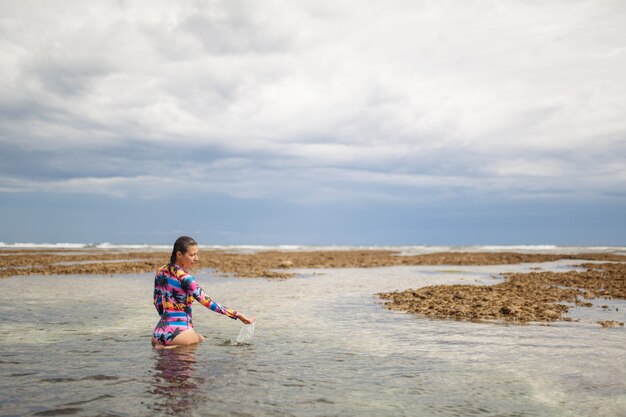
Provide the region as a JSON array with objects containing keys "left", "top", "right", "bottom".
[{"left": 378, "top": 263, "right": 626, "bottom": 327}]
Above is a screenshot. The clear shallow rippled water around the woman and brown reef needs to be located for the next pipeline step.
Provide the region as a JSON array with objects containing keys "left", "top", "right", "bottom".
[{"left": 0, "top": 261, "right": 626, "bottom": 416}]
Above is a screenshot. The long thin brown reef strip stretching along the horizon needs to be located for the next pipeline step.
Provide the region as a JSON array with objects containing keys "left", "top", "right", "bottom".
[{"left": 0, "top": 249, "right": 626, "bottom": 278}]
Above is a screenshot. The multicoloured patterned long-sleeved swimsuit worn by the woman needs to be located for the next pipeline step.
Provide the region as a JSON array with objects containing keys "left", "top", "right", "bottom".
[{"left": 153, "top": 264, "right": 239, "bottom": 346}]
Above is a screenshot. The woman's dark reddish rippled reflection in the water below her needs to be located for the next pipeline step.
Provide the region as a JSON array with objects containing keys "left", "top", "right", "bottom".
[{"left": 151, "top": 345, "right": 204, "bottom": 415}]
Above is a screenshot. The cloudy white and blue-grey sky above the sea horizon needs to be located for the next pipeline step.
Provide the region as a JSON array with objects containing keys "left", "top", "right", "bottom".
[{"left": 0, "top": 0, "right": 626, "bottom": 245}]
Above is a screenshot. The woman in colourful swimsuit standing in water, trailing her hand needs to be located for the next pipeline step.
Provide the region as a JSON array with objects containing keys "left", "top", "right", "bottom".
[{"left": 152, "top": 236, "right": 255, "bottom": 347}]
